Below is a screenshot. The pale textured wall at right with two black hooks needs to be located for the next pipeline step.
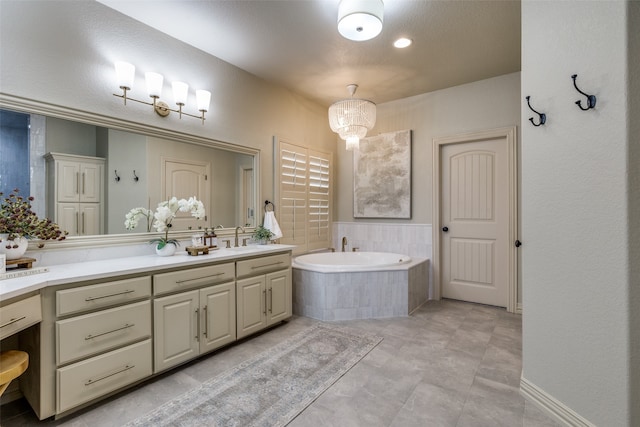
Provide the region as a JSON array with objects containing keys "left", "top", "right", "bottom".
[{"left": 521, "top": 1, "right": 640, "bottom": 427}]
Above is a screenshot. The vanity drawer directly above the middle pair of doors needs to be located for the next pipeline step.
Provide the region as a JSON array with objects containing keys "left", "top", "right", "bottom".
[{"left": 153, "top": 262, "right": 235, "bottom": 295}]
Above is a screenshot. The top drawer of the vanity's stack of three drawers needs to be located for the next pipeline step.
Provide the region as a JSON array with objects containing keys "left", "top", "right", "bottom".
[{"left": 56, "top": 276, "right": 151, "bottom": 317}]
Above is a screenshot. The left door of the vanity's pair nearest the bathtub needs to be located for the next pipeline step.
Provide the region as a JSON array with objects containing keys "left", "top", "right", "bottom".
[{"left": 236, "top": 276, "right": 267, "bottom": 338}]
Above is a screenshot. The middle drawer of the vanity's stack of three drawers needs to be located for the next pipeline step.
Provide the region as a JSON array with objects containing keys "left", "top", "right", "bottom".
[{"left": 56, "top": 301, "right": 151, "bottom": 365}]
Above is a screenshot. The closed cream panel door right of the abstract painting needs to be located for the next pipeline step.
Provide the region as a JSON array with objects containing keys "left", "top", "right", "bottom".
[{"left": 440, "top": 138, "right": 510, "bottom": 307}]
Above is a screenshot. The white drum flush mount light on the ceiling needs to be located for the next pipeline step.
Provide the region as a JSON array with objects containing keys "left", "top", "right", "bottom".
[{"left": 338, "top": 0, "right": 384, "bottom": 41}]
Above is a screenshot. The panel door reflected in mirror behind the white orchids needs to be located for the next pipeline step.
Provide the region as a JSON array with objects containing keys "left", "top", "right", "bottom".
[{"left": 162, "top": 159, "right": 211, "bottom": 230}]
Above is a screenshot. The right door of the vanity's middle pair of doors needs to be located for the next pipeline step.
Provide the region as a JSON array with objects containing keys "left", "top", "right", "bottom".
[{"left": 200, "top": 282, "right": 236, "bottom": 353}]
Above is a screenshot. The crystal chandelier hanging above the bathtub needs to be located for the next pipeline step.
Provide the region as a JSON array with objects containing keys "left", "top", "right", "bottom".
[{"left": 329, "top": 84, "right": 376, "bottom": 150}]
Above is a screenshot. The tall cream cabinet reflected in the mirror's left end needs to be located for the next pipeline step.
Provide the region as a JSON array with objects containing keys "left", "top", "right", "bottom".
[{"left": 45, "top": 153, "right": 105, "bottom": 236}]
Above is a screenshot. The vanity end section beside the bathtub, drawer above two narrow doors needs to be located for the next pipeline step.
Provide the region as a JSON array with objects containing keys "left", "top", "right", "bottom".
[{"left": 236, "top": 253, "right": 292, "bottom": 338}]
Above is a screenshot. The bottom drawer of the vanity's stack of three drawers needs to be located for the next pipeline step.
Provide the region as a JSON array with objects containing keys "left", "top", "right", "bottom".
[{"left": 56, "top": 340, "right": 151, "bottom": 413}]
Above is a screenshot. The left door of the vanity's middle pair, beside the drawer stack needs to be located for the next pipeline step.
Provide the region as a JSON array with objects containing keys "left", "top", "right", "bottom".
[{"left": 153, "top": 291, "right": 199, "bottom": 372}]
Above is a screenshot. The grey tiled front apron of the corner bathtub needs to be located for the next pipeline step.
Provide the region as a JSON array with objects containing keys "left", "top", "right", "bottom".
[{"left": 293, "top": 258, "right": 429, "bottom": 320}]
